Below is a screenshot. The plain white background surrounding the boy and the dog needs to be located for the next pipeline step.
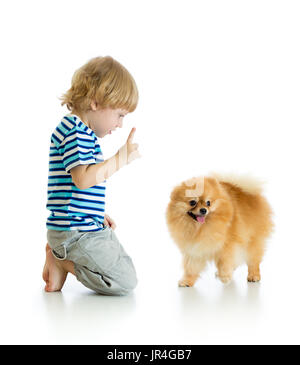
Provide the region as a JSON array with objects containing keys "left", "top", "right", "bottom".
[{"left": 0, "top": 0, "right": 300, "bottom": 344}]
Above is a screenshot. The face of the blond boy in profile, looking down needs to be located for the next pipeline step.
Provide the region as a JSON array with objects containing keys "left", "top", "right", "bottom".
[{"left": 86, "top": 103, "right": 128, "bottom": 138}]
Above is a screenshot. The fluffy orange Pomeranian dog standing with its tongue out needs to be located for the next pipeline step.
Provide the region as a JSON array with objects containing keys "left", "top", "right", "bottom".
[{"left": 166, "top": 173, "right": 274, "bottom": 287}]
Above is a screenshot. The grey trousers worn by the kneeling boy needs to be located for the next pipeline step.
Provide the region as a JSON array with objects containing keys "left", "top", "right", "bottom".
[{"left": 47, "top": 226, "right": 137, "bottom": 295}]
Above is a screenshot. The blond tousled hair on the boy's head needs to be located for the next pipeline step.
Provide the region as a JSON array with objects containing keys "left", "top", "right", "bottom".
[{"left": 59, "top": 56, "right": 138, "bottom": 112}]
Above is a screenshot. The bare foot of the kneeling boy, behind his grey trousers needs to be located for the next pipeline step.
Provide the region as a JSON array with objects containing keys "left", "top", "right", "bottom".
[{"left": 43, "top": 243, "right": 68, "bottom": 292}]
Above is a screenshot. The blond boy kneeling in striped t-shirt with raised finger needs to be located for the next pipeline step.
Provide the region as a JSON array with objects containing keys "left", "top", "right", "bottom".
[{"left": 43, "top": 56, "right": 140, "bottom": 295}]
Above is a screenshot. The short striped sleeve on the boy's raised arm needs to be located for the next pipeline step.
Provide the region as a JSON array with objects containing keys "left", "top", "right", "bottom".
[{"left": 59, "top": 125, "right": 96, "bottom": 172}]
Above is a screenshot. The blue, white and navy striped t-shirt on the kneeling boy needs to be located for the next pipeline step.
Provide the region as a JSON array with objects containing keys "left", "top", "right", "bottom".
[{"left": 46, "top": 113, "right": 106, "bottom": 232}]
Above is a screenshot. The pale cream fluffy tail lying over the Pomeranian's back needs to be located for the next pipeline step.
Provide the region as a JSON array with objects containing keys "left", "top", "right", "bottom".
[{"left": 210, "top": 172, "right": 265, "bottom": 195}]
